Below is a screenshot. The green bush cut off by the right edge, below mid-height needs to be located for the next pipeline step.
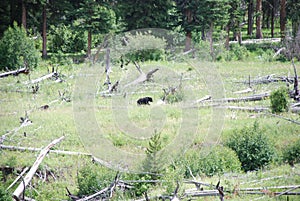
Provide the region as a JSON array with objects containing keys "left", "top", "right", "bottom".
[{"left": 283, "top": 139, "right": 300, "bottom": 165}]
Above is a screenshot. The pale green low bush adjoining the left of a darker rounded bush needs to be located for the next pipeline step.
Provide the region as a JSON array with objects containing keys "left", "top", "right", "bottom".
[{"left": 182, "top": 146, "right": 241, "bottom": 178}]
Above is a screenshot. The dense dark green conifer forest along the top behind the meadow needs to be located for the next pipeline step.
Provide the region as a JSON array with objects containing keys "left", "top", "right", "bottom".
[{"left": 0, "top": 0, "right": 300, "bottom": 66}]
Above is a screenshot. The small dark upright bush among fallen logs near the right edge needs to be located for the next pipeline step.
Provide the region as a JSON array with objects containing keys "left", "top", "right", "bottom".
[{"left": 270, "top": 87, "right": 288, "bottom": 113}]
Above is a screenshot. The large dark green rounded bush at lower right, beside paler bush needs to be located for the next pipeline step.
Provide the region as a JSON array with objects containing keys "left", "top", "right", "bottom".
[{"left": 225, "top": 122, "right": 274, "bottom": 171}]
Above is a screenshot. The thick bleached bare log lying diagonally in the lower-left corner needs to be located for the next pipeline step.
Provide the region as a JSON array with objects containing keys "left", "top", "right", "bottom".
[{"left": 13, "top": 136, "right": 64, "bottom": 201}]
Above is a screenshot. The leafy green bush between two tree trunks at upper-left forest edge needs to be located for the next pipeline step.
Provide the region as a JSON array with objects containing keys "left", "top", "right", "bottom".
[{"left": 48, "top": 24, "right": 87, "bottom": 53}]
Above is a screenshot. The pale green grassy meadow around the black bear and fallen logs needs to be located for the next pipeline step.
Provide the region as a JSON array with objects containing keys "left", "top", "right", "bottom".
[{"left": 0, "top": 57, "right": 300, "bottom": 200}]
